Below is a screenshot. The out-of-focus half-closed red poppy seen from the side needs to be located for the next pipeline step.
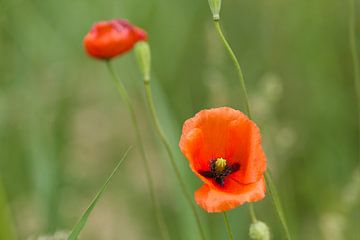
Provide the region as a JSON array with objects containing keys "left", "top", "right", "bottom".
[{"left": 84, "top": 19, "right": 147, "bottom": 59}]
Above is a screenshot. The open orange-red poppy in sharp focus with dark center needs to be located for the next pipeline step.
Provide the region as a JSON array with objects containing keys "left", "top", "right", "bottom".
[{"left": 179, "top": 107, "right": 266, "bottom": 212}]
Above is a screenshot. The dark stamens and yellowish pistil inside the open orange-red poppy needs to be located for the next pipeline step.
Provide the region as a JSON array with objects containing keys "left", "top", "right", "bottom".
[{"left": 199, "top": 158, "right": 240, "bottom": 187}]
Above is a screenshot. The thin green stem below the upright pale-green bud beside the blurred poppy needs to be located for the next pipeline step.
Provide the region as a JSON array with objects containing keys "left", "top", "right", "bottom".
[{"left": 144, "top": 79, "right": 206, "bottom": 240}]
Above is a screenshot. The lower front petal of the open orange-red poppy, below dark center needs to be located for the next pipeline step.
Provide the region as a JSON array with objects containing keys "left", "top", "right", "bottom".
[{"left": 195, "top": 177, "right": 266, "bottom": 212}]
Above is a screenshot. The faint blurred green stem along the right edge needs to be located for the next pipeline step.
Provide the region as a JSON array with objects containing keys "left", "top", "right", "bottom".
[{"left": 349, "top": 0, "right": 360, "bottom": 159}]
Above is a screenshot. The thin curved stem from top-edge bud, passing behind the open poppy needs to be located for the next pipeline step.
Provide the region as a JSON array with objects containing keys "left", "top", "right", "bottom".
[{"left": 214, "top": 20, "right": 291, "bottom": 240}]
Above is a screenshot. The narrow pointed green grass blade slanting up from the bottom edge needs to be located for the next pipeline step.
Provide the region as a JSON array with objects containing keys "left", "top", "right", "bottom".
[{"left": 68, "top": 147, "right": 131, "bottom": 240}]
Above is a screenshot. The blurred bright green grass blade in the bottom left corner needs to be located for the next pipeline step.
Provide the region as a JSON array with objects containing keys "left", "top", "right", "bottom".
[{"left": 0, "top": 176, "right": 16, "bottom": 240}]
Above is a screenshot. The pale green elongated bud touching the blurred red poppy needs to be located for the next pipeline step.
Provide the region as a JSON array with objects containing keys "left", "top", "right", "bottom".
[{"left": 135, "top": 41, "right": 151, "bottom": 81}]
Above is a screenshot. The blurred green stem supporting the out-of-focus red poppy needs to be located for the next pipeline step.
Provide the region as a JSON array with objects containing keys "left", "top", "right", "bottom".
[{"left": 106, "top": 61, "right": 170, "bottom": 240}]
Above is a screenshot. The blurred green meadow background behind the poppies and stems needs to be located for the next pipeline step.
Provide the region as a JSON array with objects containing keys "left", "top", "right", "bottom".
[{"left": 0, "top": 0, "right": 360, "bottom": 240}]
